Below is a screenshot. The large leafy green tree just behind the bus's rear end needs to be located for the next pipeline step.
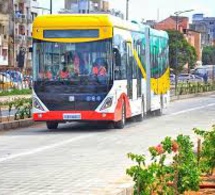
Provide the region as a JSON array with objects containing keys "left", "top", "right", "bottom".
[{"left": 167, "top": 30, "right": 197, "bottom": 75}]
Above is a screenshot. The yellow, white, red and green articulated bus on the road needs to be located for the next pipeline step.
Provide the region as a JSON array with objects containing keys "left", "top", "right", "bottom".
[{"left": 33, "top": 14, "right": 170, "bottom": 129}]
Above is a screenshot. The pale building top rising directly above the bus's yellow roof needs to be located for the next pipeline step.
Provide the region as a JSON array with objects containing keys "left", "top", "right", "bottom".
[{"left": 64, "top": 0, "right": 109, "bottom": 13}]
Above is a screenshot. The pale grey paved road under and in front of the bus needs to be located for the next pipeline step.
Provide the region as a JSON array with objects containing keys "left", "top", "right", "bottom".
[{"left": 0, "top": 95, "right": 215, "bottom": 195}]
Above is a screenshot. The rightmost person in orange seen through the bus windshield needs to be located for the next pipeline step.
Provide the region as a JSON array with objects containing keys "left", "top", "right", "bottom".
[{"left": 92, "top": 58, "right": 107, "bottom": 76}]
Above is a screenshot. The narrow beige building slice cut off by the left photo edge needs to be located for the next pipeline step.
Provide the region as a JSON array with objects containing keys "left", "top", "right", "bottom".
[{"left": 0, "top": 0, "right": 9, "bottom": 67}]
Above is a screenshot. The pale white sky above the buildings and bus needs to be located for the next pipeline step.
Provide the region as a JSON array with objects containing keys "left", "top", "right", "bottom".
[{"left": 38, "top": 0, "right": 215, "bottom": 21}]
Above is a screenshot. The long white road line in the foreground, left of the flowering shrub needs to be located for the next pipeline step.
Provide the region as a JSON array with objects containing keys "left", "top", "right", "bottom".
[{"left": 0, "top": 134, "right": 95, "bottom": 163}]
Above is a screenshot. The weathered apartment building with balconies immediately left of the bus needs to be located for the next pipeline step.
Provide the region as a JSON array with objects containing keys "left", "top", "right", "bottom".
[{"left": 13, "top": 0, "right": 38, "bottom": 69}]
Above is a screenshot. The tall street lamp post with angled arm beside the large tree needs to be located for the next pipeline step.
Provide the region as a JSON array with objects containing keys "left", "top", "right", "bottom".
[{"left": 174, "top": 9, "right": 194, "bottom": 95}]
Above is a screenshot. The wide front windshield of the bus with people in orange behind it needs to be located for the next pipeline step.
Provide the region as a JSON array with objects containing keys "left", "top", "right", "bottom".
[{"left": 33, "top": 39, "right": 111, "bottom": 84}]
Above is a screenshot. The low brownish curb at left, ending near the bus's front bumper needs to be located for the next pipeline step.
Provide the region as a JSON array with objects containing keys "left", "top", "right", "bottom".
[{"left": 0, "top": 118, "right": 34, "bottom": 131}]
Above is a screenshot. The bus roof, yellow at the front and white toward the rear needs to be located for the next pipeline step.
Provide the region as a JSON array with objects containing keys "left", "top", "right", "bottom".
[{"left": 33, "top": 14, "right": 168, "bottom": 38}]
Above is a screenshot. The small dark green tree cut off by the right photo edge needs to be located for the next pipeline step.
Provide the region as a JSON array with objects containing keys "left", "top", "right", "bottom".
[{"left": 202, "top": 46, "right": 215, "bottom": 64}]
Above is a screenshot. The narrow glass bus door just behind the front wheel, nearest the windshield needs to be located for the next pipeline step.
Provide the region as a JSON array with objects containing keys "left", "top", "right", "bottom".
[{"left": 126, "top": 42, "right": 133, "bottom": 99}]
